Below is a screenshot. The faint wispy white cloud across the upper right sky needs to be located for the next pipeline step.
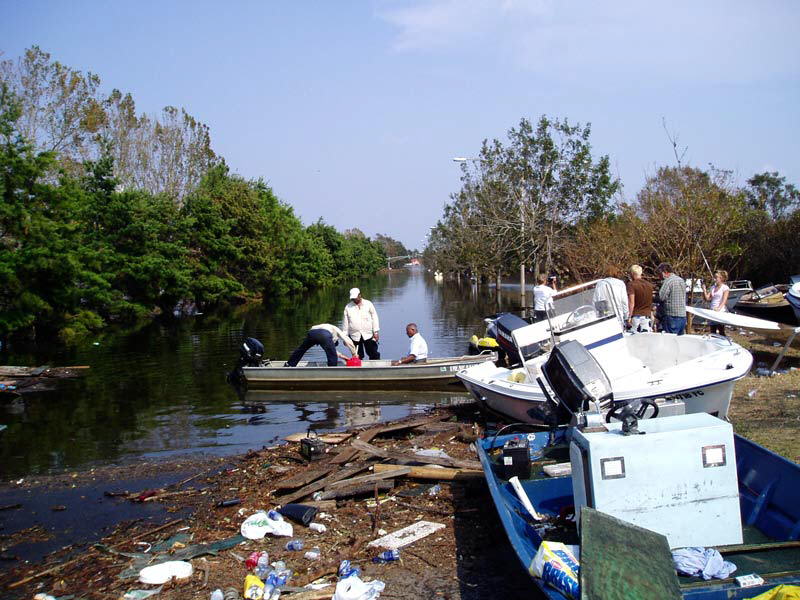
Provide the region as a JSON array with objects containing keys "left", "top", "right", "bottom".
[{"left": 376, "top": 0, "right": 800, "bottom": 84}]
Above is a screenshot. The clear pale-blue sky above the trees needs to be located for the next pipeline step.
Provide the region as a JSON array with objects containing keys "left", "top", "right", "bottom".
[{"left": 0, "top": 0, "right": 800, "bottom": 247}]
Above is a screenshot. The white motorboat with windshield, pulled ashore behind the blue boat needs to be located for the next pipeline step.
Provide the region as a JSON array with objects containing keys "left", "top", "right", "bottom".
[{"left": 457, "top": 282, "right": 753, "bottom": 424}]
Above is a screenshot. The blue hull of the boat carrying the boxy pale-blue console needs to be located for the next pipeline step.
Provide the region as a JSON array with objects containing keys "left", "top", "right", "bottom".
[{"left": 478, "top": 429, "right": 800, "bottom": 600}]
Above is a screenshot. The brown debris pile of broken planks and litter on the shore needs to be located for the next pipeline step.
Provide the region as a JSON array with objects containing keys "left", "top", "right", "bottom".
[{"left": 0, "top": 405, "right": 536, "bottom": 600}]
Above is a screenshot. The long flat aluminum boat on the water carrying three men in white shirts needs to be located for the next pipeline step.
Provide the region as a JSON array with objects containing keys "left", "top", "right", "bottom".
[{"left": 242, "top": 352, "right": 497, "bottom": 390}]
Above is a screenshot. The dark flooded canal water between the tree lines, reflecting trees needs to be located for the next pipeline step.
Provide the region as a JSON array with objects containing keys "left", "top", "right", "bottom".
[{"left": 0, "top": 269, "right": 515, "bottom": 479}]
